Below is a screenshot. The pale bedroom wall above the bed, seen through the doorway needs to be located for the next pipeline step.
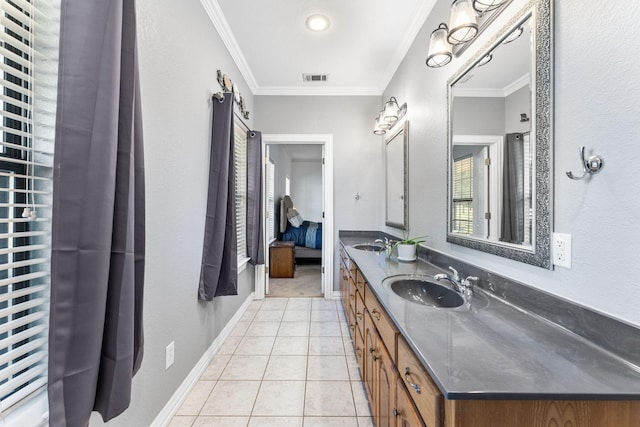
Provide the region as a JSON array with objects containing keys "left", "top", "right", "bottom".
[{"left": 291, "top": 159, "right": 322, "bottom": 222}]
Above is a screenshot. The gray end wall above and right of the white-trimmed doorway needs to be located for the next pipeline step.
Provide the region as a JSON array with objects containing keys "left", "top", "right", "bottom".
[{"left": 254, "top": 96, "right": 384, "bottom": 289}]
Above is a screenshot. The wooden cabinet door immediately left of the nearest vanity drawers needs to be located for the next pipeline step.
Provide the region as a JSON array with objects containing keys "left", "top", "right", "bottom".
[{"left": 375, "top": 344, "right": 397, "bottom": 427}]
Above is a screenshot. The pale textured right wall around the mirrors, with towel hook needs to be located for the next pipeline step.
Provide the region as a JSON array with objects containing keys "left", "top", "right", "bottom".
[{"left": 379, "top": 0, "right": 640, "bottom": 325}]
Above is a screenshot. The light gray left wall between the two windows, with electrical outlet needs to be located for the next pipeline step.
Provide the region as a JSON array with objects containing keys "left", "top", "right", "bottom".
[{"left": 91, "top": 0, "right": 254, "bottom": 427}]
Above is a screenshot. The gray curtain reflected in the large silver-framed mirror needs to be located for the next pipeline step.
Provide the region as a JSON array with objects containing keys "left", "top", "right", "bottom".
[{"left": 500, "top": 133, "right": 525, "bottom": 243}]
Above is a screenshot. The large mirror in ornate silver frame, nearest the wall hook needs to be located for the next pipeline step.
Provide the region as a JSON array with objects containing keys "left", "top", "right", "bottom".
[{"left": 447, "top": 0, "right": 552, "bottom": 268}]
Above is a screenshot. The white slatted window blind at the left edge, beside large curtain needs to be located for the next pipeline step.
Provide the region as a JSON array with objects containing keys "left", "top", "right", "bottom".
[{"left": 0, "top": 0, "right": 60, "bottom": 418}]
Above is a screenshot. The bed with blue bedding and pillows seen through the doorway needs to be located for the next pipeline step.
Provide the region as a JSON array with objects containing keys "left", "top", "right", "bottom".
[{"left": 279, "top": 196, "right": 322, "bottom": 260}]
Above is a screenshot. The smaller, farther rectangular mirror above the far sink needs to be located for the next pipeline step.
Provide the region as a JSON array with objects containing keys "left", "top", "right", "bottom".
[{"left": 384, "top": 121, "right": 409, "bottom": 230}]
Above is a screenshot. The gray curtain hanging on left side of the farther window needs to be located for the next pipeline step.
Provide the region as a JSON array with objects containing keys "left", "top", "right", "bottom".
[{"left": 198, "top": 93, "right": 238, "bottom": 301}]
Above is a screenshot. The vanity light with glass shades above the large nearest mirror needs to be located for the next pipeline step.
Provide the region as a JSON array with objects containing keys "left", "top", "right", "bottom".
[{"left": 427, "top": 0, "right": 511, "bottom": 68}]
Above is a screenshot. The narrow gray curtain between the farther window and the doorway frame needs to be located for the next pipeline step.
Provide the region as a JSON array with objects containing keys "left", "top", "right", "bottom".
[{"left": 247, "top": 131, "right": 264, "bottom": 265}]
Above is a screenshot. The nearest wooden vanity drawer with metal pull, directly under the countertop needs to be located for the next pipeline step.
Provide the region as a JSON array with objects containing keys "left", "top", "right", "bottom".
[{"left": 398, "top": 337, "right": 444, "bottom": 427}]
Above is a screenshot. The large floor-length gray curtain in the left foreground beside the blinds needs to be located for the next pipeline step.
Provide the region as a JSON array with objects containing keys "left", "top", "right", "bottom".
[{"left": 48, "top": 0, "right": 145, "bottom": 426}]
